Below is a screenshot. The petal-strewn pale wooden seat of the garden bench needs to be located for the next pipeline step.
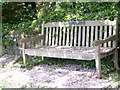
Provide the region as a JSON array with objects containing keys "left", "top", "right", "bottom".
[{"left": 25, "top": 46, "right": 114, "bottom": 60}]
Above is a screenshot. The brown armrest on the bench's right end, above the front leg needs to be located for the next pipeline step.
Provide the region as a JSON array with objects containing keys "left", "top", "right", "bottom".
[{"left": 92, "top": 35, "right": 116, "bottom": 46}]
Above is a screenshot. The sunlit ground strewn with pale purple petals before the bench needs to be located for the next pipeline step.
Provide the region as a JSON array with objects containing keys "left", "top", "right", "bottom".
[{"left": 0, "top": 56, "right": 118, "bottom": 88}]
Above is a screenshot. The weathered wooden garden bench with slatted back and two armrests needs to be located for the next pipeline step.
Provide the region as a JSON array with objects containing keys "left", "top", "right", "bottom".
[{"left": 20, "top": 19, "right": 118, "bottom": 77}]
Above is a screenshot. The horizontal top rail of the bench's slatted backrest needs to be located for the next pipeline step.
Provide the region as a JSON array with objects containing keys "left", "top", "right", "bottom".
[{"left": 45, "top": 20, "right": 115, "bottom": 27}]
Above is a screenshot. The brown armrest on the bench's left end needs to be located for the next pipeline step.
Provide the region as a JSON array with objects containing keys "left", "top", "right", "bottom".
[{"left": 19, "top": 35, "right": 45, "bottom": 43}]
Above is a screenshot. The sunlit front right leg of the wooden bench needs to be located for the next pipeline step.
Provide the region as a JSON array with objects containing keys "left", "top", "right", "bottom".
[{"left": 95, "top": 47, "right": 102, "bottom": 78}]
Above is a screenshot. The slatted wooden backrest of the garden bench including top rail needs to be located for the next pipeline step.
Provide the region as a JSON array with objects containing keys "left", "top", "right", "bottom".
[{"left": 42, "top": 19, "right": 117, "bottom": 47}]
